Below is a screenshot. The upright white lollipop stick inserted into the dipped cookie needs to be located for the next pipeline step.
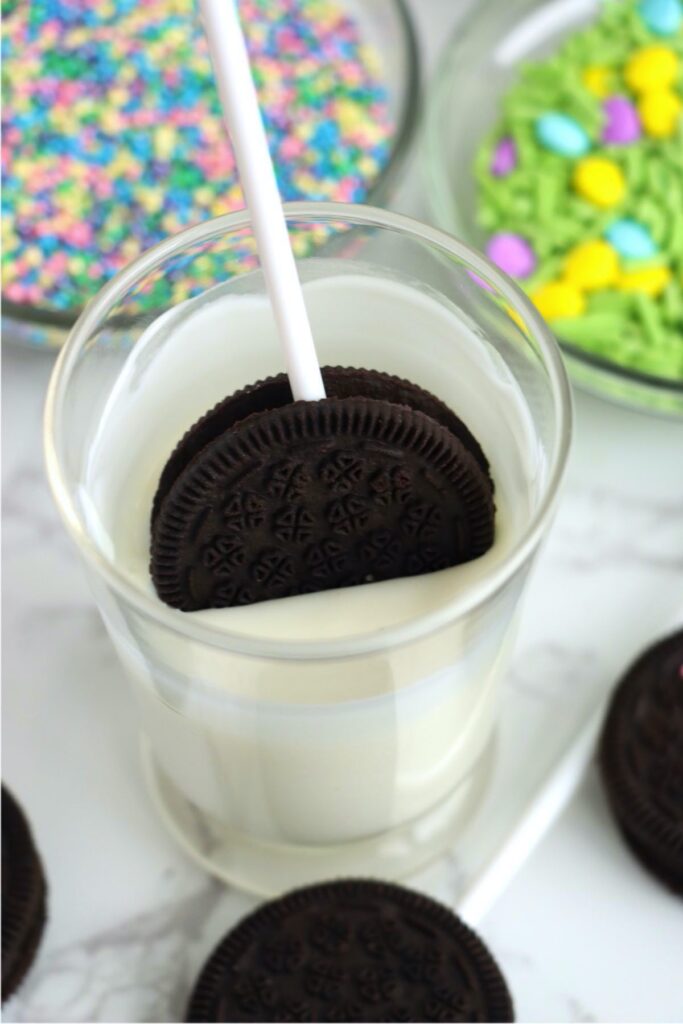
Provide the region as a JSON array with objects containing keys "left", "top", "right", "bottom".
[{"left": 201, "top": 0, "right": 325, "bottom": 401}]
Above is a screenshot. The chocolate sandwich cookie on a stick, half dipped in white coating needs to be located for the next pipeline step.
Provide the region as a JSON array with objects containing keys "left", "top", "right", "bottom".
[{"left": 151, "top": 368, "right": 495, "bottom": 611}]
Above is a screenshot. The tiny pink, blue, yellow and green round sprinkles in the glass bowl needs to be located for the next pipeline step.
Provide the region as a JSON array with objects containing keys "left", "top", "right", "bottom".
[{"left": 2, "top": 0, "right": 393, "bottom": 311}]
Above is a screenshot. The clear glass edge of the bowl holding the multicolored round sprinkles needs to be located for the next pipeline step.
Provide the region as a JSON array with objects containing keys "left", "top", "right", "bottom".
[{"left": 2, "top": 0, "right": 420, "bottom": 348}]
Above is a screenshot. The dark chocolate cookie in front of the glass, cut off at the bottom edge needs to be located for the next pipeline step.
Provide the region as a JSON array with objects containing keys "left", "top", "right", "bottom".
[{"left": 187, "top": 881, "right": 514, "bottom": 1021}]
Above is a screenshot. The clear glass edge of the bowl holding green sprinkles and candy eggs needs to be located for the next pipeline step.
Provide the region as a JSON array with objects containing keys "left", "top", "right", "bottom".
[{"left": 423, "top": 0, "right": 683, "bottom": 417}]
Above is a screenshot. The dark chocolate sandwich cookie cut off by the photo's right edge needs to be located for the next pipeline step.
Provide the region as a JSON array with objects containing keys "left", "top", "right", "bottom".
[{"left": 600, "top": 631, "right": 683, "bottom": 895}]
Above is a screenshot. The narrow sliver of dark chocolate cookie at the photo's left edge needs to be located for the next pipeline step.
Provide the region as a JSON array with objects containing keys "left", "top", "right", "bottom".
[{"left": 2, "top": 785, "right": 46, "bottom": 1002}]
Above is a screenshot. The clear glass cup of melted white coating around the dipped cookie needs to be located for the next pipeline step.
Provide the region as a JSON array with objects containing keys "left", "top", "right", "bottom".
[{"left": 45, "top": 197, "right": 571, "bottom": 893}]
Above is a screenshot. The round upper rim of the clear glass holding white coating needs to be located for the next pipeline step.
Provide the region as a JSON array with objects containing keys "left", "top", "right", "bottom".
[{"left": 43, "top": 202, "right": 572, "bottom": 660}]
